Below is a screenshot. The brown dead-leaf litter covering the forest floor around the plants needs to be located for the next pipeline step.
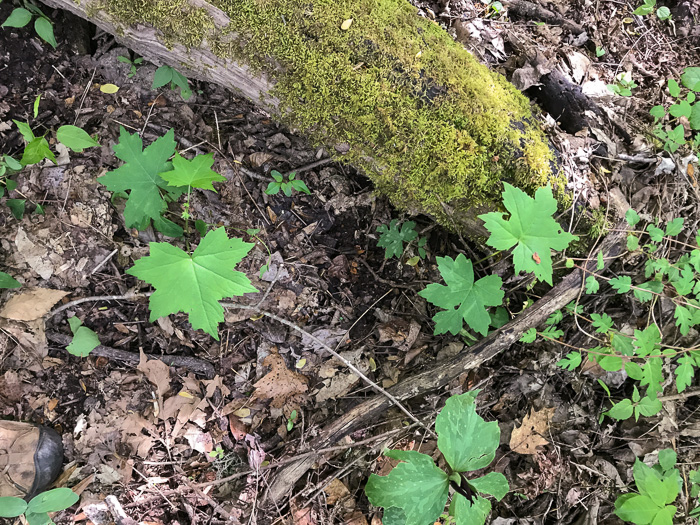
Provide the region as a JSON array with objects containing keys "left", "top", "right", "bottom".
[{"left": 0, "top": 0, "right": 700, "bottom": 525}]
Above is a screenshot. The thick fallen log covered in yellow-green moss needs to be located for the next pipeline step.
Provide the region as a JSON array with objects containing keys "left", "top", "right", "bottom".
[{"left": 38, "top": 0, "right": 564, "bottom": 235}]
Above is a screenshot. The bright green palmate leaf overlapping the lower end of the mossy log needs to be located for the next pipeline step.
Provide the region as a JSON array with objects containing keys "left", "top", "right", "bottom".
[{"left": 479, "top": 182, "right": 577, "bottom": 284}]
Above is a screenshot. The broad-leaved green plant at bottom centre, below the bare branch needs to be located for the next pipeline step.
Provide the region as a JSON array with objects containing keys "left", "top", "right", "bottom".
[{"left": 365, "top": 390, "right": 509, "bottom": 525}]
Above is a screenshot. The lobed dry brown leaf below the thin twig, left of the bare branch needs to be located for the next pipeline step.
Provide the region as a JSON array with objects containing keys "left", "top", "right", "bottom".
[{"left": 253, "top": 353, "right": 309, "bottom": 408}]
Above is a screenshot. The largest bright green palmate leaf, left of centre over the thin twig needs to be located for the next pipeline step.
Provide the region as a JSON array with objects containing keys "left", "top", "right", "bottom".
[{"left": 126, "top": 228, "right": 257, "bottom": 341}]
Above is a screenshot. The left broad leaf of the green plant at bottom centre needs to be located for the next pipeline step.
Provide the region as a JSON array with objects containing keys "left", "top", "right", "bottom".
[{"left": 365, "top": 450, "right": 449, "bottom": 525}]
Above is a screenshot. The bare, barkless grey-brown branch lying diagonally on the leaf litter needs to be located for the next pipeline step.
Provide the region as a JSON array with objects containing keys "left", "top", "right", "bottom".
[{"left": 265, "top": 221, "right": 626, "bottom": 504}]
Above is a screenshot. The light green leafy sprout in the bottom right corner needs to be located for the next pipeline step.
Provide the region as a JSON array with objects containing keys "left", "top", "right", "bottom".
[{"left": 615, "top": 449, "right": 683, "bottom": 525}]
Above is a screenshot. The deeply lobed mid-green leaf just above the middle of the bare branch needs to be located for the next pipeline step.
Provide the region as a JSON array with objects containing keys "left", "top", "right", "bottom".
[{"left": 418, "top": 253, "right": 504, "bottom": 335}]
